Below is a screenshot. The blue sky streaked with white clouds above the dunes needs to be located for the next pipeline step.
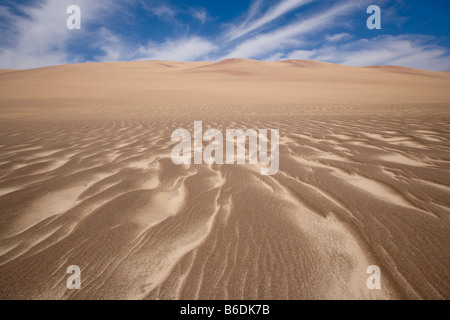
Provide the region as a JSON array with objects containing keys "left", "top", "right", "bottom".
[{"left": 0, "top": 0, "right": 450, "bottom": 71}]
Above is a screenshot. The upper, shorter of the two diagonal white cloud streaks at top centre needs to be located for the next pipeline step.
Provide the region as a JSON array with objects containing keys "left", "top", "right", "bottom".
[{"left": 227, "top": 0, "right": 313, "bottom": 40}]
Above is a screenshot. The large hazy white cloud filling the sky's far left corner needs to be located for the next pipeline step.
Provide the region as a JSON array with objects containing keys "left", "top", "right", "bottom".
[{"left": 0, "top": 0, "right": 122, "bottom": 69}]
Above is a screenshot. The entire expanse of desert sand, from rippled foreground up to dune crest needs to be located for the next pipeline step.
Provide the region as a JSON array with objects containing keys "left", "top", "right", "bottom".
[{"left": 0, "top": 60, "right": 450, "bottom": 299}]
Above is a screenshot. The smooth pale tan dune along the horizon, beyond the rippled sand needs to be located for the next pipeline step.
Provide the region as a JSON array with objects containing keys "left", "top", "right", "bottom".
[{"left": 0, "top": 59, "right": 450, "bottom": 109}]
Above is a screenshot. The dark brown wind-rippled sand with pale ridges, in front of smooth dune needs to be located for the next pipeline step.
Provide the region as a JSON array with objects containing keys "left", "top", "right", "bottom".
[{"left": 0, "top": 116, "right": 450, "bottom": 299}]
